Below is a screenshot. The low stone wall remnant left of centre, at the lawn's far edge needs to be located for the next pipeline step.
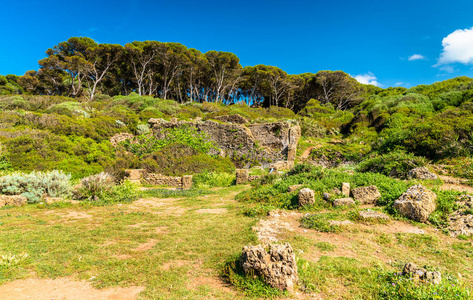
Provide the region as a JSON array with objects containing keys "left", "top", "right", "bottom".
[{"left": 125, "top": 169, "right": 192, "bottom": 189}]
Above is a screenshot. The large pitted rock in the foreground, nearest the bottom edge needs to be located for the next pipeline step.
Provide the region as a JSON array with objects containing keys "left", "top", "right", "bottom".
[{"left": 240, "top": 243, "right": 299, "bottom": 292}]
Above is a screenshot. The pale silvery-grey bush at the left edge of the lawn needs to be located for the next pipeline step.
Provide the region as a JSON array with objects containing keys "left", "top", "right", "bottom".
[{"left": 0, "top": 170, "right": 72, "bottom": 203}]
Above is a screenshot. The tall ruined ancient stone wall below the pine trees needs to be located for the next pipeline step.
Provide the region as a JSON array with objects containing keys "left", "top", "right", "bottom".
[{"left": 148, "top": 119, "right": 301, "bottom": 167}]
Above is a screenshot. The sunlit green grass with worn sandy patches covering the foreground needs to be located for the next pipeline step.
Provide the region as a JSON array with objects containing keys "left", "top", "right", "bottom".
[{"left": 0, "top": 174, "right": 473, "bottom": 299}]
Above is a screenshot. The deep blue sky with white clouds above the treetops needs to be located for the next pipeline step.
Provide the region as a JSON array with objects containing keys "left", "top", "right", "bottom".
[{"left": 0, "top": 0, "right": 473, "bottom": 87}]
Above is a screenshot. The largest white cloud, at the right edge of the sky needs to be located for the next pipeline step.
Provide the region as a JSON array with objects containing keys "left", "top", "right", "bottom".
[{"left": 436, "top": 27, "right": 473, "bottom": 66}]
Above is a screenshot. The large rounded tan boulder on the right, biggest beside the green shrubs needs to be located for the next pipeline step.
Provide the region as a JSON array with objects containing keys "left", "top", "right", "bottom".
[{"left": 394, "top": 185, "right": 437, "bottom": 222}]
